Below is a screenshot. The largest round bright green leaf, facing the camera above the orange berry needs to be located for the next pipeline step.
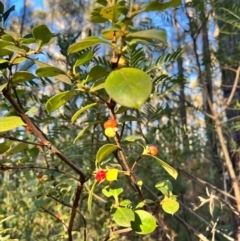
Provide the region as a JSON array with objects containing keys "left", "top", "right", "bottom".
[{"left": 105, "top": 68, "right": 152, "bottom": 109}]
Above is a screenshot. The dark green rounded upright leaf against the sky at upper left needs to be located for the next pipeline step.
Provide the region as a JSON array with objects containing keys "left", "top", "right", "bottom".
[{"left": 32, "top": 24, "right": 53, "bottom": 48}]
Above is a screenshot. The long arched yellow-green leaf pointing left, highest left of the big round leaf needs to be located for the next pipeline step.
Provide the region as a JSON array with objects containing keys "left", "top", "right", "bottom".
[{"left": 68, "top": 36, "right": 110, "bottom": 54}]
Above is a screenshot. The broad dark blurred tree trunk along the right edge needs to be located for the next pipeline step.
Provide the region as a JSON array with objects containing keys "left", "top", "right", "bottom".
[{"left": 217, "top": 0, "right": 240, "bottom": 241}]
